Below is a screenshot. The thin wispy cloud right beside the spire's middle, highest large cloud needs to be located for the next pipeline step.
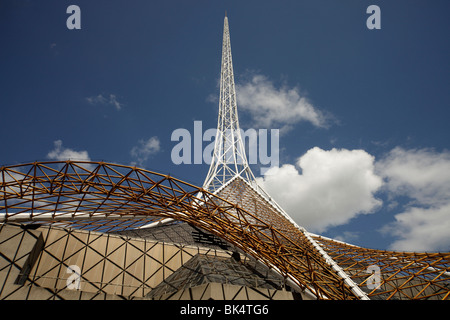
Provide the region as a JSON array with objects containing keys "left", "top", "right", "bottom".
[{"left": 236, "top": 75, "right": 328, "bottom": 131}]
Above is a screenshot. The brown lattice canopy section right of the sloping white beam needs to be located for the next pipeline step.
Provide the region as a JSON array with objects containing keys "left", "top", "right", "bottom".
[{"left": 313, "top": 235, "right": 450, "bottom": 300}]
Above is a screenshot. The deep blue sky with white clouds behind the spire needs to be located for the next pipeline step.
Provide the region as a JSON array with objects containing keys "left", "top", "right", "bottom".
[{"left": 0, "top": 0, "right": 450, "bottom": 251}]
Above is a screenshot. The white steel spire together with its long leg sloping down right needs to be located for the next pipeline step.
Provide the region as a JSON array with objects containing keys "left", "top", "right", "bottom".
[{"left": 203, "top": 14, "right": 368, "bottom": 299}]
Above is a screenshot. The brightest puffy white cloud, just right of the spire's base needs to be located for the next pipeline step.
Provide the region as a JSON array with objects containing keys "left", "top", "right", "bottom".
[{"left": 258, "top": 147, "right": 382, "bottom": 232}]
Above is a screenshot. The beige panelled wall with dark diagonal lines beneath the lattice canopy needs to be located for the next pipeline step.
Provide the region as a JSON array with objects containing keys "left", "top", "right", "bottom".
[{"left": 0, "top": 224, "right": 298, "bottom": 300}]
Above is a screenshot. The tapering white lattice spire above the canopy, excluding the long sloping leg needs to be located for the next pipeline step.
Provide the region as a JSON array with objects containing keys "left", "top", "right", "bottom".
[{"left": 203, "top": 13, "right": 255, "bottom": 192}]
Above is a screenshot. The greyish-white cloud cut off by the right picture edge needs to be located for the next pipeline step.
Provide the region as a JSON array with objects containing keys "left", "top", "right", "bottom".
[{"left": 377, "top": 148, "right": 450, "bottom": 251}]
